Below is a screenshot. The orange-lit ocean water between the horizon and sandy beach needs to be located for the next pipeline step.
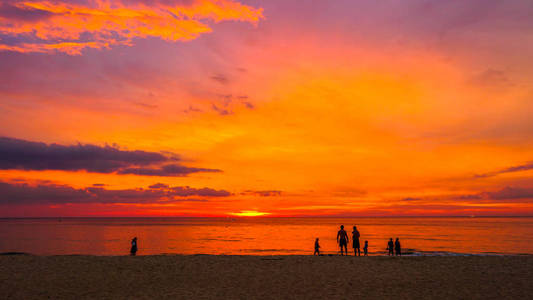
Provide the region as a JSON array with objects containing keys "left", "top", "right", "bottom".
[{"left": 0, "top": 217, "right": 533, "bottom": 255}]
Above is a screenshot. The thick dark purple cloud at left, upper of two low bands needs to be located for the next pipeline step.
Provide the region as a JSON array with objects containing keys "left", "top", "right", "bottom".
[{"left": 0, "top": 137, "right": 221, "bottom": 176}]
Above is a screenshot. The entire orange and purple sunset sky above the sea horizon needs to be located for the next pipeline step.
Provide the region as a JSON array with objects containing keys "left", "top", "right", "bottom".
[{"left": 0, "top": 0, "right": 533, "bottom": 217}]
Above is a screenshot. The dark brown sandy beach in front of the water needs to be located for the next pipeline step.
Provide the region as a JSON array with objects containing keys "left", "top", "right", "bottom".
[{"left": 0, "top": 255, "right": 533, "bottom": 299}]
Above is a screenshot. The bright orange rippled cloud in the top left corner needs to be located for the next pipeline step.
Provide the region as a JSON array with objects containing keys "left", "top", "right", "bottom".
[{"left": 0, "top": 0, "right": 263, "bottom": 55}]
